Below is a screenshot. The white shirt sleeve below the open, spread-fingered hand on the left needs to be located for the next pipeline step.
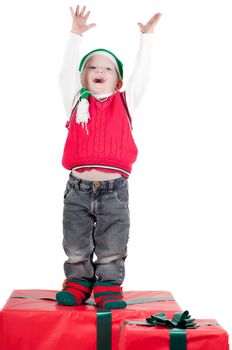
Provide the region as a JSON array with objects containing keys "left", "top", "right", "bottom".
[{"left": 59, "top": 32, "right": 82, "bottom": 119}]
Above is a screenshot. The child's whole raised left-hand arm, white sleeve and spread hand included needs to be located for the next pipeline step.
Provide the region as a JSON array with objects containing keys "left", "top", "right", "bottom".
[{"left": 59, "top": 5, "right": 96, "bottom": 118}]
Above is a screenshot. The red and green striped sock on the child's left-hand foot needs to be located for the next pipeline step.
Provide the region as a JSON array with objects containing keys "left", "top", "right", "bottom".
[{"left": 56, "top": 278, "right": 92, "bottom": 306}]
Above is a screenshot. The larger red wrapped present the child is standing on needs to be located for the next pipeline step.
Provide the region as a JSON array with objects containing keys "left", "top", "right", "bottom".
[{"left": 0, "top": 290, "right": 180, "bottom": 350}]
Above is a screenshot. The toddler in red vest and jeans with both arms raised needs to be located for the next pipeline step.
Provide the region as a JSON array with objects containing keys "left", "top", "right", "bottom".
[{"left": 56, "top": 6, "right": 161, "bottom": 309}]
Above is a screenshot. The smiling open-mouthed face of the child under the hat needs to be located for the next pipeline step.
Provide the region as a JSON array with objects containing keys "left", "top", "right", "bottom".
[{"left": 81, "top": 55, "right": 119, "bottom": 94}]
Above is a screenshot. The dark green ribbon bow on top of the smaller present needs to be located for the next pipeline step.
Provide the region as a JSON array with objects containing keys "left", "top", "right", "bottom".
[{"left": 146, "top": 310, "right": 197, "bottom": 329}]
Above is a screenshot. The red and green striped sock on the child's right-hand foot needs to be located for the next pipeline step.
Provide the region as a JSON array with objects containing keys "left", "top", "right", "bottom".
[{"left": 93, "top": 282, "right": 126, "bottom": 309}]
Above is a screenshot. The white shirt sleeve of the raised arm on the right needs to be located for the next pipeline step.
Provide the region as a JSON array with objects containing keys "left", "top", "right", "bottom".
[{"left": 126, "top": 33, "right": 153, "bottom": 113}]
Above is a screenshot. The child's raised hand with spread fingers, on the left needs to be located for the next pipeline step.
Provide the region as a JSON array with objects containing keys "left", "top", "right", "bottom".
[{"left": 70, "top": 5, "right": 96, "bottom": 35}]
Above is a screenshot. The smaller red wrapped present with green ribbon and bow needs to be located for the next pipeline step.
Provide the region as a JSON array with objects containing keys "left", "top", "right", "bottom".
[{"left": 118, "top": 311, "right": 229, "bottom": 350}]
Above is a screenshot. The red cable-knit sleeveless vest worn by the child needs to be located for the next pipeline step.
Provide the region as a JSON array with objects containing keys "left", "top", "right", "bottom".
[{"left": 62, "top": 91, "right": 138, "bottom": 176}]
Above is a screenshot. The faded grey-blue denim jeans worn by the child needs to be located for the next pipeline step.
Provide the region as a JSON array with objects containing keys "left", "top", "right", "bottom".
[{"left": 63, "top": 174, "right": 130, "bottom": 284}]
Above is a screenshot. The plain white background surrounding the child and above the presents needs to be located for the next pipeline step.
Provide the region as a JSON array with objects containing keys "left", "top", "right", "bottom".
[{"left": 0, "top": 0, "right": 232, "bottom": 344}]
